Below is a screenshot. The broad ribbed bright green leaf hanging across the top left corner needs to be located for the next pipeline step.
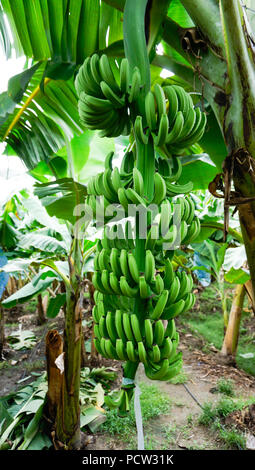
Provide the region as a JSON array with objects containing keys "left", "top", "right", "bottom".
[{"left": 1, "top": 0, "right": 122, "bottom": 64}]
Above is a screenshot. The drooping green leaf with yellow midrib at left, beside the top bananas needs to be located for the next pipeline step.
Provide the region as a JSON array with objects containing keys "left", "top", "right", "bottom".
[{"left": 0, "top": 64, "right": 83, "bottom": 169}]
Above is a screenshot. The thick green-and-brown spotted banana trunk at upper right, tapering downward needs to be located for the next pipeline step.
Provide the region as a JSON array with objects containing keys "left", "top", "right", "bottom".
[{"left": 178, "top": 0, "right": 255, "bottom": 302}]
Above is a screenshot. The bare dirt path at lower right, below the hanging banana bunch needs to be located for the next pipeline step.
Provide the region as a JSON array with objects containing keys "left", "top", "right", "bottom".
[{"left": 88, "top": 334, "right": 255, "bottom": 450}]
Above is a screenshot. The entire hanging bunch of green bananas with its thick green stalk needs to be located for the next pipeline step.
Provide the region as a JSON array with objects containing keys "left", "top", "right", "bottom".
[{"left": 71, "top": 0, "right": 206, "bottom": 430}]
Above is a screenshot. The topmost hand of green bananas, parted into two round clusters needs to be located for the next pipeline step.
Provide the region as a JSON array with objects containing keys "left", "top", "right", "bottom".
[{"left": 75, "top": 54, "right": 206, "bottom": 155}]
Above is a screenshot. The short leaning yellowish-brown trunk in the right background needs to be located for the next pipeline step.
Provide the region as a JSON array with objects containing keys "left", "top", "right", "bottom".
[{"left": 221, "top": 284, "right": 245, "bottom": 356}]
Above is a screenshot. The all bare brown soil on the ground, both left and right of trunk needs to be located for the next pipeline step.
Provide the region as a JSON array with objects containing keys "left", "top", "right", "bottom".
[{"left": 0, "top": 296, "right": 255, "bottom": 450}]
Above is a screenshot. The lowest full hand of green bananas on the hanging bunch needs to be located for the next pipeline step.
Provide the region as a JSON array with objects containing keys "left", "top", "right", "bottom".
[{"left": 93, "top": 280, "right": 186, "bottom": 380}]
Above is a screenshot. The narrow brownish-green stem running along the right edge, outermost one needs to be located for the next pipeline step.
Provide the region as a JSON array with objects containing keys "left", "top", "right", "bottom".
[{"left": 218, "top": 0, "right": 255, "bottom": 302}]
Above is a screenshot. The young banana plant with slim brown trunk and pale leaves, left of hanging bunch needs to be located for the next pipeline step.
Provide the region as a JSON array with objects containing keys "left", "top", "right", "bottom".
[{"left": 1, "top": 178, "right": 95, "bottom": 448}]
